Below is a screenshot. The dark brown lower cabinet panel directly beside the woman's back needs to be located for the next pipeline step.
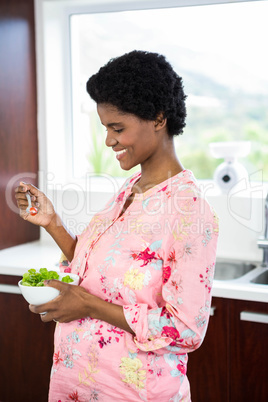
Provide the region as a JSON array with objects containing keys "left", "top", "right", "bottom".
[{"left": 187, "top": 298, "right": 229, "bottom": 402}]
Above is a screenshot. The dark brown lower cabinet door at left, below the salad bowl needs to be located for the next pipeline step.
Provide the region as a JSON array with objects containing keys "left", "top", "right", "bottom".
[{"left": 0, "top": 275, "right": 55, "bottom": 402}]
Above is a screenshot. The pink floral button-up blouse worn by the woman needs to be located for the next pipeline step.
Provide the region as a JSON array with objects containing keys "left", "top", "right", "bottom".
[{"left": 49, "top": 170, "right": 218, "bottom": 402}]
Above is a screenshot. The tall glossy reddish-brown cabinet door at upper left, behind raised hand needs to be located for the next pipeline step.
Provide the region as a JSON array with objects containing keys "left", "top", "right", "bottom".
[{"left": 0, "top": 0, "right": 40, "bottom": 249}]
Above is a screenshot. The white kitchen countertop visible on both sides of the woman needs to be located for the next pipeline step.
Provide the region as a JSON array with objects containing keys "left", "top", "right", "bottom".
[{"left": 0, "top": 241, "right": 268, "bottom": 303}]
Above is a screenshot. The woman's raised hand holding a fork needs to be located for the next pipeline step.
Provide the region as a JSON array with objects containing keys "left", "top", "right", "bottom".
[{"left": 15, "top": 182, "right": 57, "bottom": 228}]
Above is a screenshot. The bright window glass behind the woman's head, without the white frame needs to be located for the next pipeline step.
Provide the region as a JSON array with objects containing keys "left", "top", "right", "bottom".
[{"left": 70, "top": 1, "right": 268, "bottom": 180}]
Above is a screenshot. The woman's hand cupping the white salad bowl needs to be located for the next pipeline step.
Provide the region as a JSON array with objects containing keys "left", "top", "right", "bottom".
[{"left": 29, "top": 279, "right": 95, "bottom": 322}]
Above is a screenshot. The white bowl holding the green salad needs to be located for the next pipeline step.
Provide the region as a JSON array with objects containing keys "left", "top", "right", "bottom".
[{"left": 18, "top": 272, "right": 80, "bottom": 306}]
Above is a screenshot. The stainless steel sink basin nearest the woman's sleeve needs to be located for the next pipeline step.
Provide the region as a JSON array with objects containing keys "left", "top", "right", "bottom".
[{"left": 214, "top": 261, "right": 255, "bottom": 283}]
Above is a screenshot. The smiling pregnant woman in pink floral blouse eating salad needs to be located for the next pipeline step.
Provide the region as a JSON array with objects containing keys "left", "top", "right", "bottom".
[{"left": 16, "top": 51, "right": 218, "bottom": 402}]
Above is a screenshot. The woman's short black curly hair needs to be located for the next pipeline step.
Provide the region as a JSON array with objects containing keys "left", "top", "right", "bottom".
[{"left": 87, "top": 50, "right": 186, "bottom": 136}]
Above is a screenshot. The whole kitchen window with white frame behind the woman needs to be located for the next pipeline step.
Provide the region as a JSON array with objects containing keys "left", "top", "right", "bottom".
[{"left": 36, "top": 0, "right": 268, "bottom": 182}]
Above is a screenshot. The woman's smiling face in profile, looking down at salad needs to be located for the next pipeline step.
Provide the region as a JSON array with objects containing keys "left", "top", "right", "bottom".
[{"left": 97, "top": 103, "right": 168, "bottom": 170}]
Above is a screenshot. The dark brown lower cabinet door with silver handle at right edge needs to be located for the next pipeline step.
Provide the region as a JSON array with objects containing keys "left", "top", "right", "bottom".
[{"left": 230, "top": 300, "right": 268, "bottom": 402}]
